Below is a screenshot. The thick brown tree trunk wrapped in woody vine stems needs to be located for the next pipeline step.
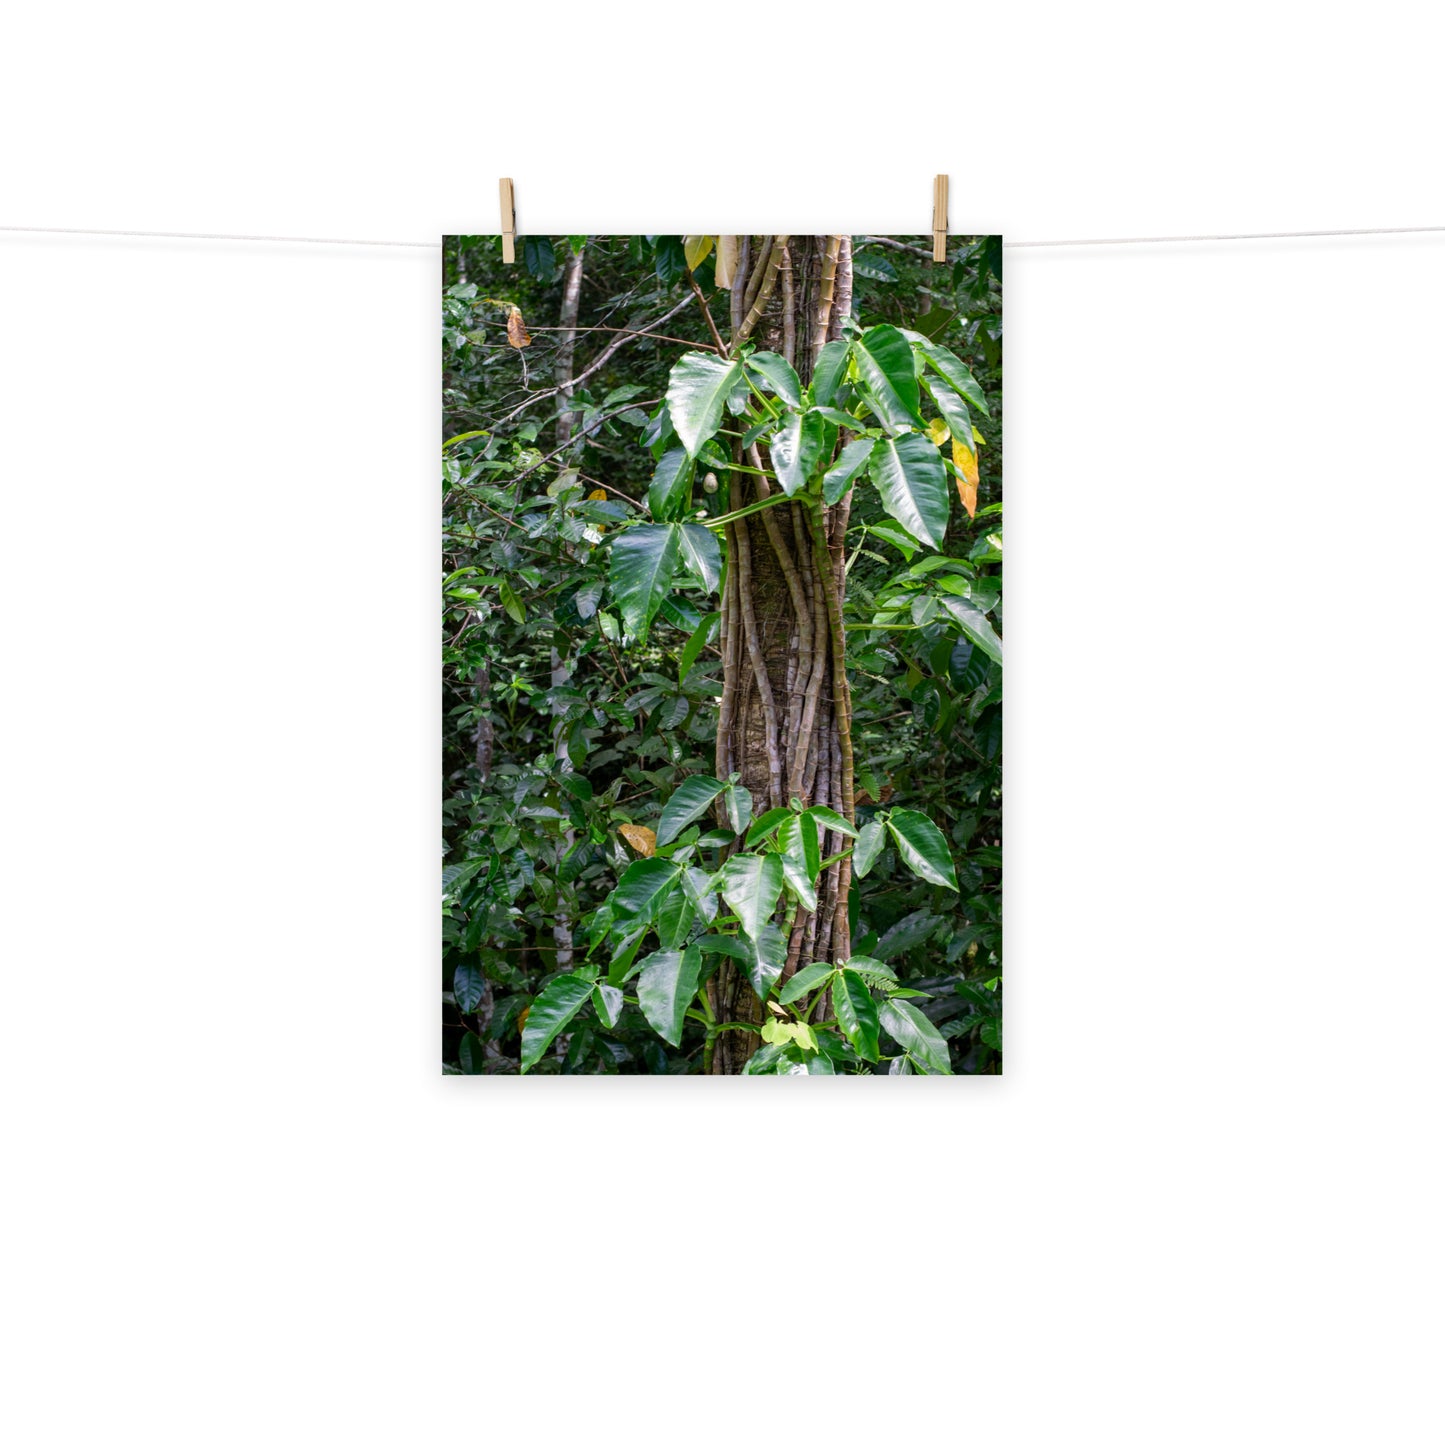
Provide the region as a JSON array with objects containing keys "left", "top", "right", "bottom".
[{"left": 708, "top": 236, "right": 854, "bottom": 1074}]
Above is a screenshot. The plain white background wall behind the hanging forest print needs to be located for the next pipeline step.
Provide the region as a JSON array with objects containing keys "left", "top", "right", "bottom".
[{"left": 0, "top": 0, "right": 1445, "bottom": 1445}]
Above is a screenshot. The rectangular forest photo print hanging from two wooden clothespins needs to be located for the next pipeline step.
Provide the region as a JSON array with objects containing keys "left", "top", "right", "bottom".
[{"left": 441, "top": 236, "right": 1003, "bottom": 1078}]
